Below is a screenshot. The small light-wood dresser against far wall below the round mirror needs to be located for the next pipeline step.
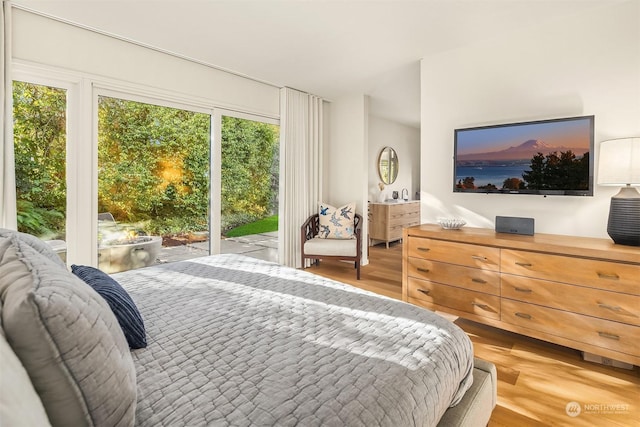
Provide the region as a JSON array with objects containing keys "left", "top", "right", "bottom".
[{"left": 369, "top": 200, "right": 420, "bottom": 248}]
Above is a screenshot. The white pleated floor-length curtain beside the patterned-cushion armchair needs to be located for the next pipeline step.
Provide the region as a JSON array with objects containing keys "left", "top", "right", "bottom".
[{"left": 278, "top": 88, "right": 323, "bottom": 268}]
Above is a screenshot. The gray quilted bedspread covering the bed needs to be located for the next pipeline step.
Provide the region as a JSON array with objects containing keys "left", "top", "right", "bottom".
[{"left": 114, "top": 255, "right": 473, "bottom": 427}]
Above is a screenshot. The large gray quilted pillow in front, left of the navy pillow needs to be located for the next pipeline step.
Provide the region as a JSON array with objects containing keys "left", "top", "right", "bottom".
[{"left": 0, "top": 233, "right": 136, "bottom": 427}]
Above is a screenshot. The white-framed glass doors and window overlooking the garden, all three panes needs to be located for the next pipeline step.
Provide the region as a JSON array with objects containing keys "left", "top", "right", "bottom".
[{"left": 13, "top": 75, "right": 279, "bottom": 273}]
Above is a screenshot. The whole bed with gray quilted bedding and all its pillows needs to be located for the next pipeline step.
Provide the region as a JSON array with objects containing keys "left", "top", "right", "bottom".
[{"left": 0, "top": 229, "right": 496, "bottom": 427}]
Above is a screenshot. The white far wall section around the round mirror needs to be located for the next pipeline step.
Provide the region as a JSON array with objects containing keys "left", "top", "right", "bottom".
[{"left": 367, "top": 116, "right": 420, "bottom": 201}]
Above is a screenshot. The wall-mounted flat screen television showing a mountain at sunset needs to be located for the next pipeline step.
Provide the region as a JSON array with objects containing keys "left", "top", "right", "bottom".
[{"left": 453, "top": 116, "right": 594, "bottom": 196}]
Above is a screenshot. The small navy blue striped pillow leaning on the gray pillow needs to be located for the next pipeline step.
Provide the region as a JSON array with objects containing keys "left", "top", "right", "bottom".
[{"left": 71, "top": 264, "right": 147, "bottom": 349}]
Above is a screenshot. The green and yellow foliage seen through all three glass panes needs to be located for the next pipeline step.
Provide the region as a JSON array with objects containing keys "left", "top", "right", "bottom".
[{"left": 13, "top": 82, "right": 278, "bottom": 237}]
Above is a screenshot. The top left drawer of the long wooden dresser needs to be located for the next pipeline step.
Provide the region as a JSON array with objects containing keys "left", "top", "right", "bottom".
[{"left": 408, "top": 237, "right": 500, "bottom": 271}]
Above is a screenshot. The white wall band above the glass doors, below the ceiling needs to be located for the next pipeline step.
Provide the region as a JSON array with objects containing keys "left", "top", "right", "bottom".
[{"left": 12, "top": 8, "right": 280, "bottom": 117}]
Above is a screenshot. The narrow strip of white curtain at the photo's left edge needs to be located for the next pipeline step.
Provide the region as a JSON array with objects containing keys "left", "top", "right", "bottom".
[{"left": 0, "top": 1, "right": 17, "bottom": 230}]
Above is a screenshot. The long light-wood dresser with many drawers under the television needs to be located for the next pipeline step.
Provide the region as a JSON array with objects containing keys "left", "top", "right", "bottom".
[{"left": 402, "top": 224, "right": 640, "bottom": 365}]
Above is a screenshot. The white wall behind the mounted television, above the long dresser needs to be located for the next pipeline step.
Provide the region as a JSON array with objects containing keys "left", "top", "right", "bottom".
[{"left": 420, "top": 1, "right": 640, "bottom": 237}]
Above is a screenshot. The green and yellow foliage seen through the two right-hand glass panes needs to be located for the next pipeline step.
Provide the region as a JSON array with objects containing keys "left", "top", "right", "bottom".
[{"left": 98, "top": 97, "right": 278, "bottom": 234}]
